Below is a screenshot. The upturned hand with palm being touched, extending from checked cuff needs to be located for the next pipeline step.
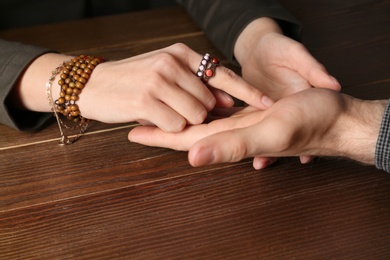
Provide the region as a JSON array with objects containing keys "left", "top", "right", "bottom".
[{"left": 129, "top": 89, "right": 385, "bottom": 169}]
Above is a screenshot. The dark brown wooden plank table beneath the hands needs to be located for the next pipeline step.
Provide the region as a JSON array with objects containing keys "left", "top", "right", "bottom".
[{"left": 0, "top": 0, "right": 390, "bottom": 259}]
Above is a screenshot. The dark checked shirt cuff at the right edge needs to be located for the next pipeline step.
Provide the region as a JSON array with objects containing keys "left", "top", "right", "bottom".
[{"left": 375, "top": 100, "right": 390, "bottom": 172}]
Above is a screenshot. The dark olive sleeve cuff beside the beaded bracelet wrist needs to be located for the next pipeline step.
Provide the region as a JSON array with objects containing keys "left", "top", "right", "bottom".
[{"left": 0, "top": 39, "right": 55, "bottom": 131}]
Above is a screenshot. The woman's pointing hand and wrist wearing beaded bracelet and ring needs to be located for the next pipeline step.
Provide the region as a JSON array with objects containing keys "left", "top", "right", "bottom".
[{"left": 14, "top": 44, "right": 272, "bottom": 132}]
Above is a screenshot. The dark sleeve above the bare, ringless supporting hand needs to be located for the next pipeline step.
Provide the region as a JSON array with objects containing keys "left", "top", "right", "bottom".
[{"left": 177, "top": 0, "right": 302, "bottom": 62}]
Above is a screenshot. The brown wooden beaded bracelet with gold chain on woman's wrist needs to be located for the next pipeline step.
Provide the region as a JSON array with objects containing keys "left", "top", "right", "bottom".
[{"left": 46, "top": 55, "right": 105, "bottom": 145}]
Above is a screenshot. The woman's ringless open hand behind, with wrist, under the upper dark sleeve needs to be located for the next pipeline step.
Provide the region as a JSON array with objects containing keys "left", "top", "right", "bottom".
[{"left": 234, "top": 18, "right": 341, "bottom": 101}]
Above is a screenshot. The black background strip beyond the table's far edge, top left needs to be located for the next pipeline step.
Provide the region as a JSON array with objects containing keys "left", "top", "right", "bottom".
[{"left": 0, "top": 0, "right": 176, "bottom": 30}]
